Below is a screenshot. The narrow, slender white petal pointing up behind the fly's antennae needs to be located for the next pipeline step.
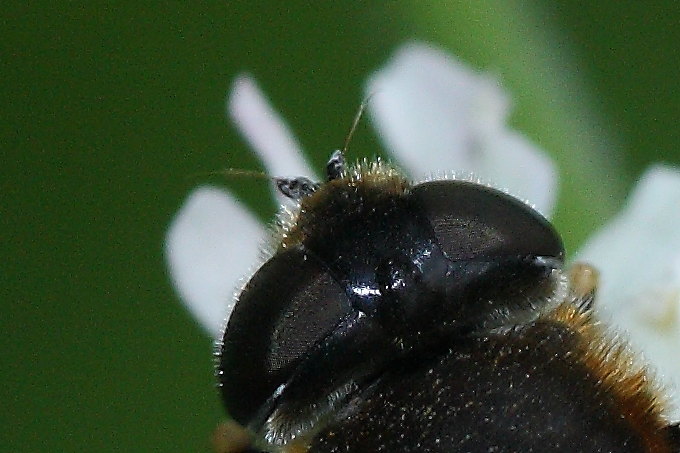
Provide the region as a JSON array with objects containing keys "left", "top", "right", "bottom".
[{"left": 227, "top": 75, "right": 314, "bottom": 177}]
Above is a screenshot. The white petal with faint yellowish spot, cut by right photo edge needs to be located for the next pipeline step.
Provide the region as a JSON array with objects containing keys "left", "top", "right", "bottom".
[{"left": 577, "top": 166, "right": 680, "bottom": 419}]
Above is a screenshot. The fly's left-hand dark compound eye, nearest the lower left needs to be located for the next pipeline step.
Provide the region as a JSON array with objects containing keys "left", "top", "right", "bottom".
[{"left": 218, "top": 245, "right": 352, "bottom": 425}]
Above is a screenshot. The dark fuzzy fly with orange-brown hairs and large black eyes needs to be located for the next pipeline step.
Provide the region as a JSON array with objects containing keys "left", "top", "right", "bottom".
[{"left": 218, "top": 153, "right": 680, "bottom": 452}]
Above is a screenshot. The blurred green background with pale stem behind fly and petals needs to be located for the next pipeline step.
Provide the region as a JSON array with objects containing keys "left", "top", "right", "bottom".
[{"left": 0, "top": 0, "right": 680, "bottom": 452}]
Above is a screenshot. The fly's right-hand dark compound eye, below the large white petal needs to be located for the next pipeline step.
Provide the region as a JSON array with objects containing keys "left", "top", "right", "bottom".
[{"left": 411, "top": 181, "right": 564, "bottom": 261}]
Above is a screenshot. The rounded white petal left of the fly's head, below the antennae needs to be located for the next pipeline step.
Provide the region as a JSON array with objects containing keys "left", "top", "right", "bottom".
[{"left": 165, "top": 187, "right": 266, "bottom": 335}]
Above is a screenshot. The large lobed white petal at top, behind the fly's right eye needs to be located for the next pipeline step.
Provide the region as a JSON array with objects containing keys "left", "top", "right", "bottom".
[{"left": 367, "top": 44, "right": 556, "bottom": 215}]
